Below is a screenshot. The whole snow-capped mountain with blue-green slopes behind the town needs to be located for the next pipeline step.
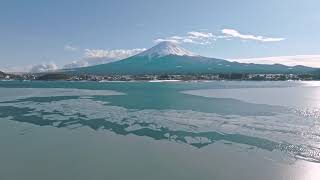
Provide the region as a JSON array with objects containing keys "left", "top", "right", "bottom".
[{"left": 68, "top": 42, "right": 316, "bottom": 75}]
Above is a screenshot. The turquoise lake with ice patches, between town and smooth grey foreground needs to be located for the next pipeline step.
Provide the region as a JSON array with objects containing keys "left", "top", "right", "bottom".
[{"left": 0, "top": 81, "right": 320, "bottom": 179}]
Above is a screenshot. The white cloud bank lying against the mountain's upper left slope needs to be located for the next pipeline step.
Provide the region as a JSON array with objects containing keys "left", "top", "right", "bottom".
[{"left": 64, "top": 48, "right": 146, "bottom": 69}]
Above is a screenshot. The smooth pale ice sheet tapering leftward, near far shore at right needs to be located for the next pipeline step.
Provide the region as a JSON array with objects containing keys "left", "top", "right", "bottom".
[{"left": 182, "top": 87, "right": 320, "bottom": 109}]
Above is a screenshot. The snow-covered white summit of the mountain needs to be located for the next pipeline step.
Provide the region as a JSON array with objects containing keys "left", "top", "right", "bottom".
[{"left": 138, "top": 41, "right": 195, "bottom": 57}]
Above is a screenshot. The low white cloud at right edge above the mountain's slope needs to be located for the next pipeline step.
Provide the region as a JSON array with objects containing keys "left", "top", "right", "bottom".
[{"left": 233, "top": 54, "right": 320, "bottom": 68}]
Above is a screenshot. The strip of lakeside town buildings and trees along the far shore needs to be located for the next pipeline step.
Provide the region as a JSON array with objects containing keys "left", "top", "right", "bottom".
[{"left": 0, "top": 72, "right": 320, "bottom": 81}]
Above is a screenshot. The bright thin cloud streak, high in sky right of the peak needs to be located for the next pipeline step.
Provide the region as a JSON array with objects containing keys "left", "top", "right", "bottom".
[{"left": 221, "top": 29, "right": 285, "bottom": 42}]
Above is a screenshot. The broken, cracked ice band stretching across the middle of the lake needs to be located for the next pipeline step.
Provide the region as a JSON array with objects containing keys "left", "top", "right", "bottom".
[{"left": 0, "top": 95, "right": 320, "bottom": 161}]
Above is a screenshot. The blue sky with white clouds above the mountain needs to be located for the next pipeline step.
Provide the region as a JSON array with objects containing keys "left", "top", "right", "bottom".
[{"left": 0, "top": 0, "right": 320, "bottom": 71}]
